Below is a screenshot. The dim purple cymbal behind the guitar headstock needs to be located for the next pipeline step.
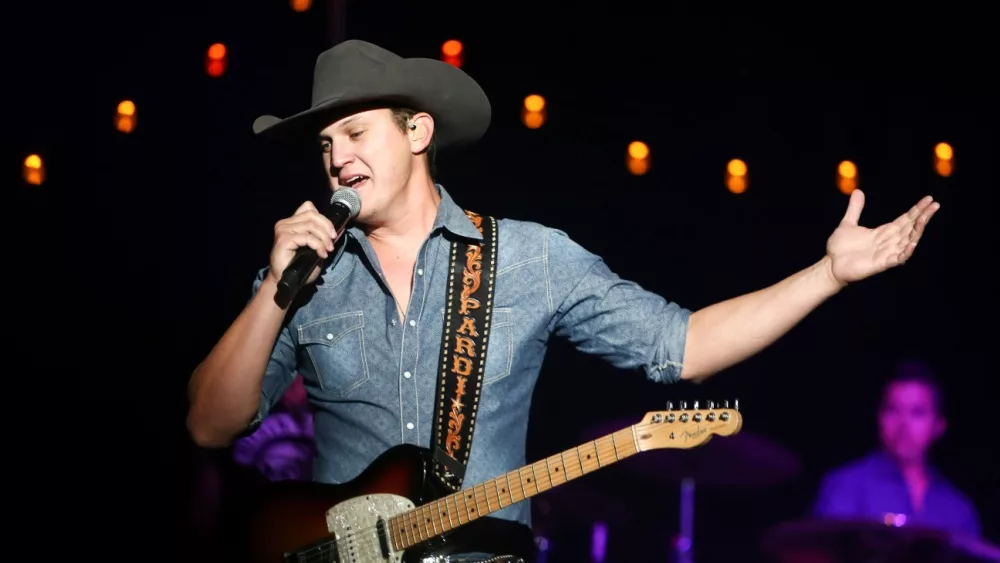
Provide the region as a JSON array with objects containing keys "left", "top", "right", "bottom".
[{"left": 583, "top": 419, "right": 802, "bottom": 488}]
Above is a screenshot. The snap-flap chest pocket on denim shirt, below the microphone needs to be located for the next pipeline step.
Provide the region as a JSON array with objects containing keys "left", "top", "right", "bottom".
[{"left": 299, "top": 311, "right": 370, "bottom": 399}]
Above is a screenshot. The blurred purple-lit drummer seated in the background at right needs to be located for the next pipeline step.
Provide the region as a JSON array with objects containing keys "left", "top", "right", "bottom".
[{"left": 815, "top": 362, "right": 980, "bottom": 537}]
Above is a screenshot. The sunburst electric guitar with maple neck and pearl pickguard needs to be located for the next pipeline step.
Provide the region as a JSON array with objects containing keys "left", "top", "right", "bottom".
[{"left": 238, "top": 401, "right": 743, "bottom": 563}]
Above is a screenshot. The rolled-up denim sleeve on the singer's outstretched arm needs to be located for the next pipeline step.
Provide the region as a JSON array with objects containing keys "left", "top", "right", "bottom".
[{"left": 545, "top": 230, "right": 691, "bottom": 383}]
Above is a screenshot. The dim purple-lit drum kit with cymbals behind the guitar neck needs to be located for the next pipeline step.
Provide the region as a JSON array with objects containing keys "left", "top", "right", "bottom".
[{"left": 536, "top": 412, "right": 1000, "bottom": 563}]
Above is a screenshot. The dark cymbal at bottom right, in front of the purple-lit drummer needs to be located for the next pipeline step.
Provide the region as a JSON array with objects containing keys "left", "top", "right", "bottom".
[{"left": 762, "top": 519, "right": 1000, "bottom": 563}]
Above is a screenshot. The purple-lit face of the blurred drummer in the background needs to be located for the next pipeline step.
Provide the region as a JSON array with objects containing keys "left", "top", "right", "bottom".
[{"left": 878, "top": 381, "right": 945, "bottom": 462}]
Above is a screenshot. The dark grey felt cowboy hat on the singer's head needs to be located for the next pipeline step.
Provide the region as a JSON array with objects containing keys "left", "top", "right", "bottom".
[{"left": 253, "top": 39, "right": 491, "bottom": 149}]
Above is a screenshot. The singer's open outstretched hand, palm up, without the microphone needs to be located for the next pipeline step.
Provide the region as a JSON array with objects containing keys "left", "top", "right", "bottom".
[{"left": 826, "top": 190, "right": 941, "bottom": 284}]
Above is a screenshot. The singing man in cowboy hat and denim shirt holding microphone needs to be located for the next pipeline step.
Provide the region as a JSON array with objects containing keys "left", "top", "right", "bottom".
[{"left": 188, "top": 41, "right": 938, "bottom": 561}]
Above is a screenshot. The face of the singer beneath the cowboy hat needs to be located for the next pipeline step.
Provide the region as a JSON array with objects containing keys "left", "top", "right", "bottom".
[{"left": 320, "top": 109, "right": 433, "bottom": 224}]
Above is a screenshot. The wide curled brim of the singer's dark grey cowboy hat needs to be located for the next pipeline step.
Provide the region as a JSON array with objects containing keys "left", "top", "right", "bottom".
[{"left": 253, "top": 58, "right": 492, "bottom": 149}]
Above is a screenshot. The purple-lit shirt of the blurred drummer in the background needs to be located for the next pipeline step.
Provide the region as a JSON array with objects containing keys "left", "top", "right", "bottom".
[{"left": 813, "top": 451, "right": 980, "bottom": 537}]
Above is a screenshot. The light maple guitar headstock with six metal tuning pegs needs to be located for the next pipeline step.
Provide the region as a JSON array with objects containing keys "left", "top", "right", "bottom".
[{"left": 634, "top": 401, "right": 743, "bottom": 451}]
